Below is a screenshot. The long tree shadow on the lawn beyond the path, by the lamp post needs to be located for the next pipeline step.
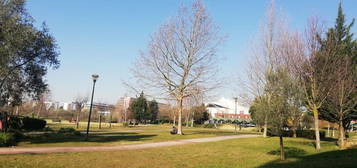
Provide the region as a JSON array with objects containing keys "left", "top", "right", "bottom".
[{"left": 25, "top": 132, "right": 157, "bottom": 144}]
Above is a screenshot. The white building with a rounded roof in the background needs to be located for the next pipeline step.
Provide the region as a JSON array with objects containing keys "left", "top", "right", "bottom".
[{"left": 206, "top": 97, "right": 251, "bottom": 119}]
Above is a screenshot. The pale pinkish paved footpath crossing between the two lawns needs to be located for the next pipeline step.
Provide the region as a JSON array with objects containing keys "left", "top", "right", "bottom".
[{"left": 0, "top": 135, "right": 260, "bottom": 155}]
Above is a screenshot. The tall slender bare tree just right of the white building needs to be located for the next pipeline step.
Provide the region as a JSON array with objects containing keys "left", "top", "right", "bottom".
[{"left": 241, "top": 1, "right": 284, "bottom": 137}]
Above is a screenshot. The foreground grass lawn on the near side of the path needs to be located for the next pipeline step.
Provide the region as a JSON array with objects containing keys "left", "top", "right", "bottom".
[{"left": 0, "top": 137, "right": 357, "bottom": 168}]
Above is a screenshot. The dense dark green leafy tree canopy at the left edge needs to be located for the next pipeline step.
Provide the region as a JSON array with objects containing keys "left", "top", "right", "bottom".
[{"left": 0, "top": 0, "right": 59, "bottom": 106}]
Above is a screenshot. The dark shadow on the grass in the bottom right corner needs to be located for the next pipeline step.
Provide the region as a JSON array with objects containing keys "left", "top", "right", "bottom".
[{"left": 259, "top": 148, "right": 357, "bottom": 168}]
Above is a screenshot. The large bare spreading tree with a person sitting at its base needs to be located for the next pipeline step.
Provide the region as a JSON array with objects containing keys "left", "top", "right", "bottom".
[{"left": 134, "top": 1, "right": 224, "bottom": 135}]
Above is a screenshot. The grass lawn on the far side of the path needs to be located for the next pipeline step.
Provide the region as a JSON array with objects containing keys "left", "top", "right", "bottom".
[{"left": 17, "top": 123, "right": 255, "bottom": 147}]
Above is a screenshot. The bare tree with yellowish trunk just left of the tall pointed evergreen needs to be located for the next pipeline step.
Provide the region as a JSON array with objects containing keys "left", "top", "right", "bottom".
[{"left": 296, "top": 17, "right": 331, "bottom": 150}]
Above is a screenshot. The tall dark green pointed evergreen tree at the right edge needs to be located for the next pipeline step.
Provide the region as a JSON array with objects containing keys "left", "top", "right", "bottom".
[{"left": 320, "top": 3, "right": 357, "bottom": 148}]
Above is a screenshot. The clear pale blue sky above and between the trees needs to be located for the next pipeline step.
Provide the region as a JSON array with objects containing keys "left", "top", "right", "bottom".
[{"left": 26, "top": 0, "right": 357, "bottom": 103}]
